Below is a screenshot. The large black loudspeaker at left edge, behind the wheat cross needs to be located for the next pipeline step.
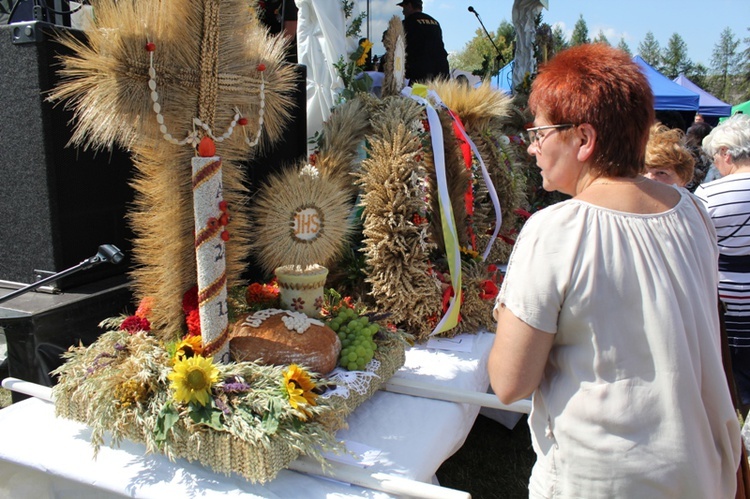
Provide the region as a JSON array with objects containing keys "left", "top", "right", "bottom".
[{"left": 0, "top": 22, "right": 133, "bottom": 289}]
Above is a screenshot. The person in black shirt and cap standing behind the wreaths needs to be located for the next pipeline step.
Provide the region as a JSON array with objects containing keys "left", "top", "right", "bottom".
[{"left": 397, "top": 0, "right": 450, "bottom": 83}]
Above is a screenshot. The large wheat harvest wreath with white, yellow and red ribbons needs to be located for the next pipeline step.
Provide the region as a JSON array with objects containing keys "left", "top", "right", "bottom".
[{"left": 310, "top": 81, "right": 526, "bottom": 341}]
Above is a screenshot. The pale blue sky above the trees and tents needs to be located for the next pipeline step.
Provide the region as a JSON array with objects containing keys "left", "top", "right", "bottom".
[{"left": 356, "top": 0, "right": 750, "bottom": 67}]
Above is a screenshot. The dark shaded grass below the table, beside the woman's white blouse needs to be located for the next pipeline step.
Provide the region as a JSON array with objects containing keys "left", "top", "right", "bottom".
[{"left": 437, "top": 415, "right": 536, "bottom": 499}]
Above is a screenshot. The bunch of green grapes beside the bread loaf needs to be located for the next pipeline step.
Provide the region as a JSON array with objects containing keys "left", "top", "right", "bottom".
[{"left": 328, "top": 307, "right": 379, "bottom": 371}]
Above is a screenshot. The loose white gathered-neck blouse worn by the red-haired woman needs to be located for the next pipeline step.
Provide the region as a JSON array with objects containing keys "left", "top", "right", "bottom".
[{"left": 498, "top": 190, "right": 740, "bottom": 499}]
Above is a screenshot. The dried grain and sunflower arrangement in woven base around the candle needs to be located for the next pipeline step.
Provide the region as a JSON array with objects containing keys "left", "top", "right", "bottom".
[{"left": 53, "top": 302, "right": 405, "bottom": 483}]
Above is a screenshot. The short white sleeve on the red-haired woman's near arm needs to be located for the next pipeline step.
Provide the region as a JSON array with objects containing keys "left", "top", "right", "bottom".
[{"left": 495, "top": 203, "right": 584, "bottom": 333}]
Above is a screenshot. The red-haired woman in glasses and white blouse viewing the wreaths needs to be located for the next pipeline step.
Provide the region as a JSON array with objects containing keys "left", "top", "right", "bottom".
[{"left": 488, "top": 44, "right": 741, "bottom": 498}]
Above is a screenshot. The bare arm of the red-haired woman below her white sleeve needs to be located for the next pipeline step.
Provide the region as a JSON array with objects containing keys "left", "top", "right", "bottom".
[{"left": 487, "top": 306, "right": 555, "bottom": 404}]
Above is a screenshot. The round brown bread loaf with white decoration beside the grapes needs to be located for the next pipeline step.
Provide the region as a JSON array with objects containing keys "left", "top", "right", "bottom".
[{"left": 229, "top": 309, "right": 341, "bottom": 375}]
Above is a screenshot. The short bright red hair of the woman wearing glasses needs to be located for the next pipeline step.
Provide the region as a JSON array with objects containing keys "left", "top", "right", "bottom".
[{"left": 529, "top": 43, "right": 654, "bottom": 177}]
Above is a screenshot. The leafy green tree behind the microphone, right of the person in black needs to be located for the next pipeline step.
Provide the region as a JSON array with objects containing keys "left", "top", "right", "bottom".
[{"left": 448, "top": 19, "right": 516, "bottom": 77}]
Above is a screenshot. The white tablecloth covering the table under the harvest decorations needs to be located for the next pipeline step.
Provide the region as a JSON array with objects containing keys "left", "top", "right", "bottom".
[{"left": 0, "top": 333, "right": 494, "bottom": 499}]
